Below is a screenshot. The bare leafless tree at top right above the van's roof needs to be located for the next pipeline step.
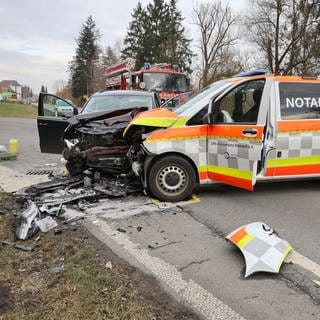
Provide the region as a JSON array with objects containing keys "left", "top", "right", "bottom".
[{"left": 247, "top": 0, "right": 320, "bottom": 74}]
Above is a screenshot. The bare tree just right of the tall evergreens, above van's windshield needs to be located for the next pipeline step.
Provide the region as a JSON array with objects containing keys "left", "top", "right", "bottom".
[{"left": 193, "top": 0, "right": 238, "bottom": 86}]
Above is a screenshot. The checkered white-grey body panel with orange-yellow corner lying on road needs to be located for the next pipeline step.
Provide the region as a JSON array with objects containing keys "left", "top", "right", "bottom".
[{"left": 226, "top": 222, "right": 292, "bottom": 277}]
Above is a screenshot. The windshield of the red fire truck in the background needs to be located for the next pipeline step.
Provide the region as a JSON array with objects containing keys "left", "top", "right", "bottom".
[{"left": 143, "top": 72, "right": 187, "bottom": 92}]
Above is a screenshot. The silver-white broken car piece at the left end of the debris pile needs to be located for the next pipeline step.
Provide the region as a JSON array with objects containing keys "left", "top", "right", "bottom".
[{"left": 14, "top": 200, "right": 39, "bottom": 240}]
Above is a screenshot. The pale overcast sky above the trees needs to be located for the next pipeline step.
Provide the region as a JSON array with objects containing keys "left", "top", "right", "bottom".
[{"left": 0, "top": 0, "right": 246, "bottom": 93}]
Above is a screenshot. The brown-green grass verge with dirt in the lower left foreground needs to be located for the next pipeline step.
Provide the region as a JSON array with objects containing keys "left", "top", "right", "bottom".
[{"left": 0, "top": 193, "right": 196, "bottom": 320}]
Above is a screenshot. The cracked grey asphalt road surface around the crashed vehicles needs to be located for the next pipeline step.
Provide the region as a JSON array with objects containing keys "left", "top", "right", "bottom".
[{"left": 0, "top": 118, "right": 320, "bottom": 320}]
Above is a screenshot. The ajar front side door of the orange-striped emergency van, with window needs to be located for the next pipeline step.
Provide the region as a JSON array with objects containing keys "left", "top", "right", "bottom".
[{"left": 207, "top": 78, "right": 270, "bottom": 190}]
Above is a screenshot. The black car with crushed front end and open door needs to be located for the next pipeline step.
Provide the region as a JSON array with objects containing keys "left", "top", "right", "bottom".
[{"left": 37, "top": 92, "right": 159, "bottom": 194}]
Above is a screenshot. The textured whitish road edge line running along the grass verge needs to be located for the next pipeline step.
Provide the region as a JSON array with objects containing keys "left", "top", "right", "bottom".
[{"left": 88, "top": 216, "right": 245, "bottom": 320}]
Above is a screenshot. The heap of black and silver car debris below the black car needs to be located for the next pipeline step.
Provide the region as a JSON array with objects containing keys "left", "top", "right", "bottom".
[{"left": 10, "top": 172, "right": 141, "bottom": 240}]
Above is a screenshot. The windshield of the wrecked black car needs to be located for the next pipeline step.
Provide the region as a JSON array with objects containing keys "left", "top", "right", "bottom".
[{"left": 81, "top": 95, "right": 153, "bottom": 113}]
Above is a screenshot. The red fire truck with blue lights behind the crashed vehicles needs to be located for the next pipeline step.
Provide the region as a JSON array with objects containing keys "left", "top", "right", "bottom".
[{"left": 105, "top": 59, "right": 190, "bottom": 101}]
